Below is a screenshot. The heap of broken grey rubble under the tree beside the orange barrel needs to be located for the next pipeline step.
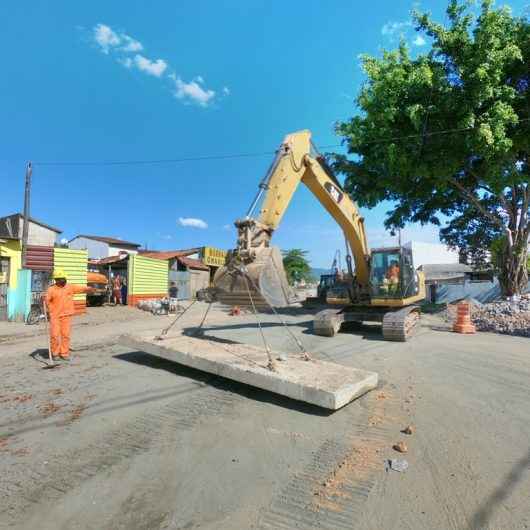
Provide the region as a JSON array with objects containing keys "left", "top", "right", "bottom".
[{"left": 471, "top": 295, "right": 530, "bottom": 337}]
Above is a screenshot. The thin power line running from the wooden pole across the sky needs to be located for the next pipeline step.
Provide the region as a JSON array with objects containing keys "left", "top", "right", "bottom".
[{"left": 29, "top": 118, "right": 530, "bottom": 166}]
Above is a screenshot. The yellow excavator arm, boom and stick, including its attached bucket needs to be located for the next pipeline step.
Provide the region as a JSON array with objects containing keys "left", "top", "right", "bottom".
[{"left": 214, "top": 131, "right": 370, "bottom": 307}]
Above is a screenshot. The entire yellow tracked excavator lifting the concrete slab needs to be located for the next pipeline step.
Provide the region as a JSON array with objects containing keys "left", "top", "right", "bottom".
[{"left": 213, "top": 130, "right": 425, "bottom": 341}]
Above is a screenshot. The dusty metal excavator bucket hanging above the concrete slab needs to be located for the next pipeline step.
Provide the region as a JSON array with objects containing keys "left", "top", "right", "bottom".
[{"left": 214, "top": 247, "right": 298, "bottom": 310}]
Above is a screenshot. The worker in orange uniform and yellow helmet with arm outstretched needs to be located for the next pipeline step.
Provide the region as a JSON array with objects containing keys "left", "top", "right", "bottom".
[{"left": 45, "top": 269, "right": 94, "bottom": 360}]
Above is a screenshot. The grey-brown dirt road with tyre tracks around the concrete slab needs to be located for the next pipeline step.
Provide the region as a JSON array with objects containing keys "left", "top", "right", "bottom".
[{"left": 0, "top": 304, "right": 530, "bottom": 530}]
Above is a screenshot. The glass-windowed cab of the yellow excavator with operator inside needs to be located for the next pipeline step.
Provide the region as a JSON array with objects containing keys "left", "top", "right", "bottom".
[{"left": 370, "top": 247, "right": 419, "bottom": 299}]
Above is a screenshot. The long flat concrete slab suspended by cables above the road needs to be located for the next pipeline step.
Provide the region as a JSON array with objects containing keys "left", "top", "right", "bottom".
[{"left": 120, "top": 334, "right": 378, "bottom": 410}]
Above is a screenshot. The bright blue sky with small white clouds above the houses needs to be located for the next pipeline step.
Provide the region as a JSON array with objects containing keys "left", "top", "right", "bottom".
[{"left": 0, "top": 0, "right": 528, "bottom": 266}]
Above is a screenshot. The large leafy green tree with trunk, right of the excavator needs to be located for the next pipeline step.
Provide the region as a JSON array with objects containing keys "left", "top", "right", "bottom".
[{"left": 332, "top": 0, "right": 530, "bottom": 294}]
